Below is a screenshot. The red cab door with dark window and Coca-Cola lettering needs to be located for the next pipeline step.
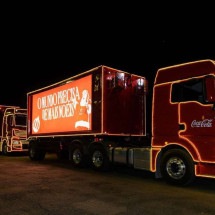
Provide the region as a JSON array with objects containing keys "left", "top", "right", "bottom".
[{"left": 172, "top": 78, "right": 215, "bottom": 162}]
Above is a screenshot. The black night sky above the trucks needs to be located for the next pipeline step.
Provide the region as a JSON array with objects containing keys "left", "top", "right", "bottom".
[{"left": 0, "top": 3, "right": 215, "bottom": 107}]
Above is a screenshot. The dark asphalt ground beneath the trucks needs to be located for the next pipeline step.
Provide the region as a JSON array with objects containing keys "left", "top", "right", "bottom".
[{"left": 0, "top": 154, "right": 215, "bottom": 215}]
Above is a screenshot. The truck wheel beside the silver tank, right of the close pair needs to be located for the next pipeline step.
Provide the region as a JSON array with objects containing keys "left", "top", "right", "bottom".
[{"left": 90, "top": 146, "right": 109, "bottom": 171}]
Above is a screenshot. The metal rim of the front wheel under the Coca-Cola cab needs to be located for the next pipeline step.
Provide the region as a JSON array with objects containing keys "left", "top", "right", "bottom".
[{"left": 166, "top": 157, "right": 186, "bottom": 179}]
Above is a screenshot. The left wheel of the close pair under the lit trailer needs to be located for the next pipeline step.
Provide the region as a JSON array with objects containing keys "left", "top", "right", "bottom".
[{"left": 69, "top": 146, "right": 84, "bottom": 167}]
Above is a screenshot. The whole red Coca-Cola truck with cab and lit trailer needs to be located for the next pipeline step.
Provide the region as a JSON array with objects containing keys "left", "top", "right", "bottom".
[{"left": 27, "top": 59, "right": 215, "bottom": 186}]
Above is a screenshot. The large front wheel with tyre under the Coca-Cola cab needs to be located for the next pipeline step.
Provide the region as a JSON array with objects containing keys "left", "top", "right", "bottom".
[{"left": 161, "top": 149, "right": 195, "bottom": 186}]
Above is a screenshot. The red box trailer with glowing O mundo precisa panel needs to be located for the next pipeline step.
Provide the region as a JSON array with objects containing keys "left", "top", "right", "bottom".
[{"left": 27, "top": 66, "right": 147, "bottom": 165}]
